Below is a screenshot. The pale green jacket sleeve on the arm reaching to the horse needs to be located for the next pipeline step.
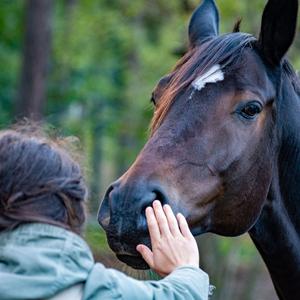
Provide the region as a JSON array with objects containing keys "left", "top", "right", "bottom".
[{"left": 83, "top": 264, "right": 209, "bottom": 300}]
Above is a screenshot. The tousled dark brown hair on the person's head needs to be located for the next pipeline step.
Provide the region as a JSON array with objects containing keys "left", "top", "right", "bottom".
[{"left": 0, "top": 127, "right": 87, "bottom": 234}]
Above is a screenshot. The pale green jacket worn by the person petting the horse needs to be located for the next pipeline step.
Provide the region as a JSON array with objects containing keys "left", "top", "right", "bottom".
[{"left": 0, "top": 223, "right": 209, "bottom": 300}]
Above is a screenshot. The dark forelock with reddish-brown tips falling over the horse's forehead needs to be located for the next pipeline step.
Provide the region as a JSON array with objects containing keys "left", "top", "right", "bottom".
[{"left": 150, "top": 32, "right": 257, "bottom": 135}]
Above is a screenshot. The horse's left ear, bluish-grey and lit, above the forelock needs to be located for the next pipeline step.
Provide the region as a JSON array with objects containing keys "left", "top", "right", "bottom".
[{"left": 189, "top": 0, "right": 219, "bottom": 47}]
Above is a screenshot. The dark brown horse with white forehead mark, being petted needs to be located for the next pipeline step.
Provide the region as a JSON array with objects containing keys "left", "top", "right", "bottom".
[{"left": 99, "top": 0, "right": 300, "bottom": 300}]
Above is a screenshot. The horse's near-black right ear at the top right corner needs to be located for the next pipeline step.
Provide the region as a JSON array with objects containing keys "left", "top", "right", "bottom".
[{"left": 259, "top": 0, "right": 298, "bottom": 66}]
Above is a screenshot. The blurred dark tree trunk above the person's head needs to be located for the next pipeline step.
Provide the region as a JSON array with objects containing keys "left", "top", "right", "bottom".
[{"left": 16, "top": 0, "right": 53, "bottom": 120}]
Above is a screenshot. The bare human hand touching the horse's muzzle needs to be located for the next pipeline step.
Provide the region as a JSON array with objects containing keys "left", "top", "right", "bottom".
[{"left": 136, "top": 200, "right": 199, "bottom": 276}]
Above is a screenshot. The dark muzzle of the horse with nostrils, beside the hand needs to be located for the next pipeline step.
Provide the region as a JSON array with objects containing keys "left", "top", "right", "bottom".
[{"left": 98, "top": 180, "right": 168, "bottom": 269}]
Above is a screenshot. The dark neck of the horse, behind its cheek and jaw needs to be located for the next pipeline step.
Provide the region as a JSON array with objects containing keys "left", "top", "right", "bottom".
[{"left": 249, "top": 72, "right": 300, "bottom": 300}]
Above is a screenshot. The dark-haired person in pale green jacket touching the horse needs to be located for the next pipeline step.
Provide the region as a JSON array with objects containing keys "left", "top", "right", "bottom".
[{"left": 0, "top": 129, "right": 209, "bottom": 300}]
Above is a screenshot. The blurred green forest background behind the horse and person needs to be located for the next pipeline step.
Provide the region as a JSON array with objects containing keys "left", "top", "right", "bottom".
[{"left": 0, "top": 0, "right": 300, "bottom": 300}]
